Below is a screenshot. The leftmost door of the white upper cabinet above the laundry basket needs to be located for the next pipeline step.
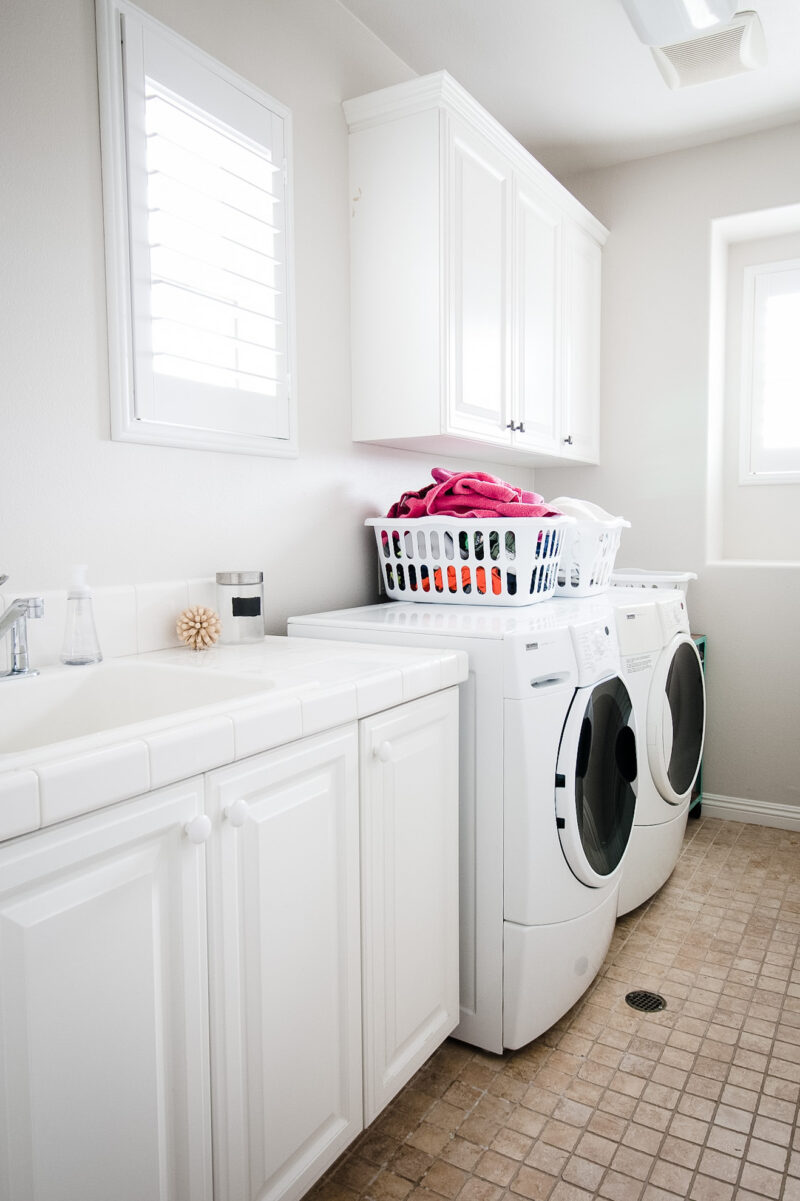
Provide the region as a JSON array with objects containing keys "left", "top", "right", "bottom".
[{"left": 444, "top": 118, "right": 511, "bottom": 444}]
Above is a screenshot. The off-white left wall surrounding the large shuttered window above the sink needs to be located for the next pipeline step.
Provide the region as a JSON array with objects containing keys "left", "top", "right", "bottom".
[{"left": 0, "top": 0, "right": 532, "bottom": 633}]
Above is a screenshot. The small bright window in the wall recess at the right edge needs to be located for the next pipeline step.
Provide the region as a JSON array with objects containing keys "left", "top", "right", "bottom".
[{"left": 740, "top": 259, "right": 800, "bottom": 483}]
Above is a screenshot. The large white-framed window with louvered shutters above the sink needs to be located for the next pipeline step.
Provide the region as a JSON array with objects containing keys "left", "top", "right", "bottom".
[{"left": 98, "top": 0, "right": 297, "bottom": 454}]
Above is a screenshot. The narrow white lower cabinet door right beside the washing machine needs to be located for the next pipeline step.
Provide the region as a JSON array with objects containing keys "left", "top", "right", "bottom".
[{"left": 360, "top": 688, "right": 459, "bottom": 1123}]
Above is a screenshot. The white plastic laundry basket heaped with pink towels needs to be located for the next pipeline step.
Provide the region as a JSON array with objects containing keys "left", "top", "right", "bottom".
[{"left": 365, "top": 516, "right": 574, "bottom": 605}]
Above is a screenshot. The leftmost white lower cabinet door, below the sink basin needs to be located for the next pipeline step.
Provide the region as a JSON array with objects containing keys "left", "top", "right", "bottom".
[{"left": 0, "top": 781, "right": 211, "bottom": 1201}]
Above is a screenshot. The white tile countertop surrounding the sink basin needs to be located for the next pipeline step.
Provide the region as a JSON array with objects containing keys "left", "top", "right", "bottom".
[{"left": 0, "top": 638, "right": 467, "bottom": 839}]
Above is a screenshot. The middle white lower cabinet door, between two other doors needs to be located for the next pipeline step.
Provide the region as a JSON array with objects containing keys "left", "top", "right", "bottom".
[{"left": 208, "top": 725, "right": 363, "bottom": 1201}]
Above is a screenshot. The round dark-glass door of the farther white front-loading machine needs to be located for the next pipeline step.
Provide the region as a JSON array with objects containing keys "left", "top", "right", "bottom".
[{"left": 647, "top": 634, "right": 705, "bottom": 805}]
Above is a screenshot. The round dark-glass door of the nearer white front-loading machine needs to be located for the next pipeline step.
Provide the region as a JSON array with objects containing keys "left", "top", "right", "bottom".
[{"left": 555, "top": 676, "right": 637, "bottom": 888}]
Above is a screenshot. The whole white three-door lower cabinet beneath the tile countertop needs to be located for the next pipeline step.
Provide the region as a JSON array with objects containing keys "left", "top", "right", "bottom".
[{"left": 0, "top": 688, "right": 459, "bottom": 1201}]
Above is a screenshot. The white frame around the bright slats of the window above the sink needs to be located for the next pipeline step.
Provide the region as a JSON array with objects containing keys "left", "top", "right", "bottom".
[{"left": 96, "top": 0, "right": 298, "bottom": 458}]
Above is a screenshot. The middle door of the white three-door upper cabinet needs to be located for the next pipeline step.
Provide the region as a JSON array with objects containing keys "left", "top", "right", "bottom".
[{"left": 513, "top": 180, "right": 562, "bottom": 454}]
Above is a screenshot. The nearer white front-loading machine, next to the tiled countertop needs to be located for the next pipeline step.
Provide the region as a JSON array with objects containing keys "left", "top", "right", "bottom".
[{"left": 288, "top": 599, "right": 637, "bottom": 1053}]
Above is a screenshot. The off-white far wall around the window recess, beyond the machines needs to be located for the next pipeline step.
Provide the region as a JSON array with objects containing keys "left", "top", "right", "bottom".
[{"left": 536, "top": 125, "right": 800, "bottom": 806}]
